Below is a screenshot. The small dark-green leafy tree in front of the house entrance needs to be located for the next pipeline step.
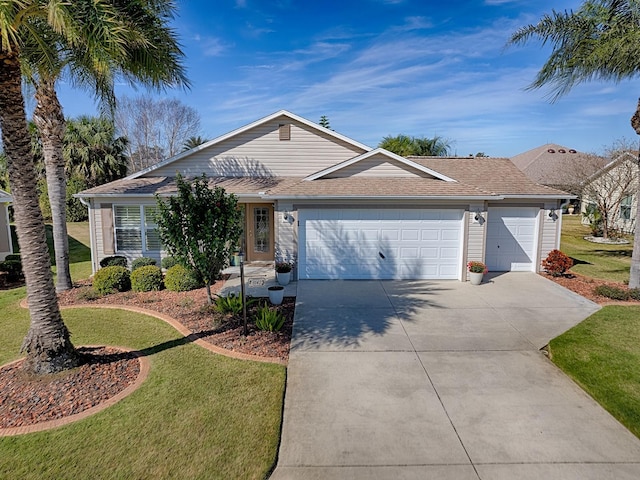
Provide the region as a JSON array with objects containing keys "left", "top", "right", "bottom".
[{"left": 157, "top": 174, "right": 242, "bottom": 305}]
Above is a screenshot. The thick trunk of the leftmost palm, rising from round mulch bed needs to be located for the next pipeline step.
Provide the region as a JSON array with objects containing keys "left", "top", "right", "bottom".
[{"left": 0, "top": 51, "right": 79, "bottom": 373}]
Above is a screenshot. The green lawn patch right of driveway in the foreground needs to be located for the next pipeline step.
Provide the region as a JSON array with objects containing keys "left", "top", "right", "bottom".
[{"left": 550, "top": 306, "right": 640, "bottom": 437}]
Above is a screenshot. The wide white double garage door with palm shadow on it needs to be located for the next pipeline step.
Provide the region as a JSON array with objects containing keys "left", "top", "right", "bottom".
[{"left": 298, "top": 208, "right": 463, "bottom": 279}]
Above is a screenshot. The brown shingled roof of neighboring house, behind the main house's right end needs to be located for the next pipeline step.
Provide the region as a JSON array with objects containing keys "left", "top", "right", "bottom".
[{"left": 511, "top": 143, "right": 609, "bottom": 194}]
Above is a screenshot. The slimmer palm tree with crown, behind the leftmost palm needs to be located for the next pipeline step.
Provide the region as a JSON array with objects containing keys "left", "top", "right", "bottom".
[{"left": 22, "top": 0, "right": 188, "bottom": 291}]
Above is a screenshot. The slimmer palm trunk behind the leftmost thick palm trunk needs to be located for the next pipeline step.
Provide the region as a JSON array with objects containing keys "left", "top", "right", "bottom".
[{"left": 33, "top": 78, "right": 73, "bottom": 292}]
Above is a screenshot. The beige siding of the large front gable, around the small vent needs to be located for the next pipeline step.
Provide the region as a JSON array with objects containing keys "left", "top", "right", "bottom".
[{"left": 151, "top": 117, "right": 364, "bottom": 177}]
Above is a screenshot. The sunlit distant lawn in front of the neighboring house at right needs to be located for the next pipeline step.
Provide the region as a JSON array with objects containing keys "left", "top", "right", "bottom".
[{"left": 560, "top": 215, "right": 633, "bottom": 283}]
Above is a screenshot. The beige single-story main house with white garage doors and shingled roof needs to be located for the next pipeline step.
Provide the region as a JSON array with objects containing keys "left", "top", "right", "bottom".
[{"left": 77, "top": 111, "right": 569, "bottom": 280}]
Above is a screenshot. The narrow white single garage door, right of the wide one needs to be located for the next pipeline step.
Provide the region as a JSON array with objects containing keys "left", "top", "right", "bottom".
[{"left": 485, "top": 207, "right": 540, "bottom": 272}]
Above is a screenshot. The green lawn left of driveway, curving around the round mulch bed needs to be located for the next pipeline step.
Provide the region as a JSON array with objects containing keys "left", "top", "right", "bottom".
[{"left": 0, "top": 224, "right": 286, "bottom": 479}]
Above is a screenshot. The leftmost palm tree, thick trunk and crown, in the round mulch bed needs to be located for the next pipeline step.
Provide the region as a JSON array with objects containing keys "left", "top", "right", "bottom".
[{"left": 0, "top": 0, "right": 186, "bottom": 373}]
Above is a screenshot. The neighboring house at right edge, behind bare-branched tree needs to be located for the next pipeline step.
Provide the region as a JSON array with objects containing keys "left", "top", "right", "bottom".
[{"left": 581, "top": 152, "right": 638, "bottom": 233}]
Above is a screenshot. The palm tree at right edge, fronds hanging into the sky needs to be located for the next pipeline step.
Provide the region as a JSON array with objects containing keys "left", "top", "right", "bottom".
[{"left": 509, "top": 0, "right": 640, "bottom": 288}]
